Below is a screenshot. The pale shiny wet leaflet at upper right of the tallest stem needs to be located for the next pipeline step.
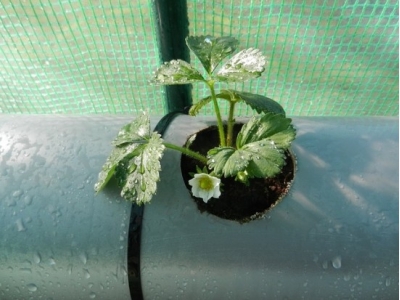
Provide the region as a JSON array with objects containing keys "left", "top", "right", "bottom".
[{"left": 215, "top": 48, "right": 266, "bottom": 82}]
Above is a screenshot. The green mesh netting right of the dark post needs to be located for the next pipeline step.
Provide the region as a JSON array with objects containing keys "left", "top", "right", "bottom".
[{"left": 188, "top": 0, "right": 399, "bottom": 115}]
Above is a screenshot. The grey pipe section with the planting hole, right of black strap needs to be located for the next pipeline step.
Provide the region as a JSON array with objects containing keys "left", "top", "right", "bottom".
[{"left": 141, "top": 117, "right": 399, "bottom": 299}]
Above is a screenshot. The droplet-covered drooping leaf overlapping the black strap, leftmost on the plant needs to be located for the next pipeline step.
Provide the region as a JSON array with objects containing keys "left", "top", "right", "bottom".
[{"left": 95, "top": 113, "right": 165, "bottom": 205}]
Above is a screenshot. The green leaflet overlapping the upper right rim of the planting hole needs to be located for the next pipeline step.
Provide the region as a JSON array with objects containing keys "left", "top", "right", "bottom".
[{"left": 236, "top": 113, "right": 296, "bottom": 150}]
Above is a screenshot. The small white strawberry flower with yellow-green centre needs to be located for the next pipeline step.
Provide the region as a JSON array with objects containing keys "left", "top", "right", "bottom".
[{"left": 189, "top": 173, "right": 221, "bottom": 203}]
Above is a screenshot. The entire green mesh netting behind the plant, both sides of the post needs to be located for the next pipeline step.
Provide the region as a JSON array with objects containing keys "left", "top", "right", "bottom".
[{"left": 0, "top": 0, "right": 399, "bottom": 116}]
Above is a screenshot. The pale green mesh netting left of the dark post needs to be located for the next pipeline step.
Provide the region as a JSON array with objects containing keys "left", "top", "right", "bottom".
[{"left": 0, "top": 0, "right": 163, "bottom": 113}]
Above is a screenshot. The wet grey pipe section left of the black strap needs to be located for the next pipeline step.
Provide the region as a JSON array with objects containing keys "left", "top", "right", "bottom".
[{"left": 0, "top": 115, "right": 138, "bottom": 300}]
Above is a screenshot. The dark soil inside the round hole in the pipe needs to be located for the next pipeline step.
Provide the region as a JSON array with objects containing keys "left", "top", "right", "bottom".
[{"left": 181, "top": 125, "right": 295, "bottom": 223}]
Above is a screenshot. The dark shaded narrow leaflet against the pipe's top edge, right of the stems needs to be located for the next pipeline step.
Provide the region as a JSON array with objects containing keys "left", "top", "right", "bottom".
[{"left": 222, "top": 90, "right": 285, "bottom": 115}]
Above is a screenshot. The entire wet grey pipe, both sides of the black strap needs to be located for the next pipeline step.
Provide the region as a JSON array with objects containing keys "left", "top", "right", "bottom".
[{"left": 0, "top": 115, "right": 399, "bottom": 300}]
